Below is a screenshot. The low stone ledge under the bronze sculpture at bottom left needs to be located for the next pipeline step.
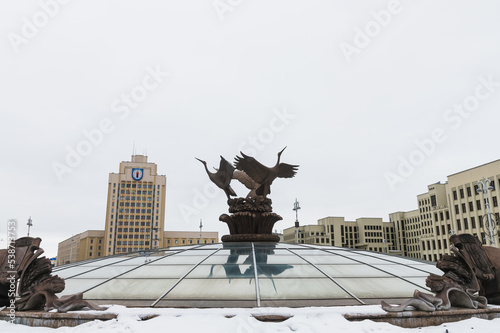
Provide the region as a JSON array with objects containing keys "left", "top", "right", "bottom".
[{"left": 0, "top": 309, "right": 116, "bottom": 328}]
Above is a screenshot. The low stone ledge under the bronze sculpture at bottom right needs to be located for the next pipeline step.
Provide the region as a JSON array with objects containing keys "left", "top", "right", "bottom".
[{"left": 344, "top": 308, "right": 500, "bottom": 328}]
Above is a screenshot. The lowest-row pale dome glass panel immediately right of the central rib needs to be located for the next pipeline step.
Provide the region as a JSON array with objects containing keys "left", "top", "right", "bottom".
[{"left": 259, "top": 278, "right": 351, "bottom": 299}]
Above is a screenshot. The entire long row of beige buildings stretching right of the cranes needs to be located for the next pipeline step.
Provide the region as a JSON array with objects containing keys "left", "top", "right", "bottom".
[{"left": 283, "top": 160, "right": 500, "bottom": 261}]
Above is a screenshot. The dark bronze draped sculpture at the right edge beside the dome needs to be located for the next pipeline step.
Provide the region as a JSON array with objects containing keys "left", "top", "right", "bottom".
[{"left": 382, "top": 234, "right": 500, "bottom": 312}]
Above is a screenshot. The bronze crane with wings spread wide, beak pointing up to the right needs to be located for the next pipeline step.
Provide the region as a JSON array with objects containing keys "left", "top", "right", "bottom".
[{"left": 235, "top": 147, "right": 299, "bottom": 197}]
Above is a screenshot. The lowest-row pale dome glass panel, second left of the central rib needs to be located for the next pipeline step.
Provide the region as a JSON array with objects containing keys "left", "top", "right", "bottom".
[{"left": 84, "top": 279, "right": 178, "bottom": 303}]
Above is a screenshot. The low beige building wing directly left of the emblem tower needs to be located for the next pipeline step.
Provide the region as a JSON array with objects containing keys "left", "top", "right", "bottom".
[{"left": 56, "top": 230, "right": 104, "bottom": 266}]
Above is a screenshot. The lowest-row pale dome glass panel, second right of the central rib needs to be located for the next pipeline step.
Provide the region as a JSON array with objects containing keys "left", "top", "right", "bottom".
[{"left": 335, "top": 278, "right": 418, "bottom": 298}]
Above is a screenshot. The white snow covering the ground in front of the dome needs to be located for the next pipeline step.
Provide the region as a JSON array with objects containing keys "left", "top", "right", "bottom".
[{"left": 0, "top": 305, "right": 500, "bottom": 333}]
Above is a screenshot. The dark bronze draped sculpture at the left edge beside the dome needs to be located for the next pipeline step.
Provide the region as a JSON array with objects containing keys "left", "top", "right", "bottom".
[{"left": 0, "top": 237, "right": 104, "bottom": 312}]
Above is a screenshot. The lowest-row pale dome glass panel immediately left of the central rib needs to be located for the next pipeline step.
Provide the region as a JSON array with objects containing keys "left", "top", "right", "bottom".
[{"left": 165, "top": 279, "right": 256, "bottom": 300}]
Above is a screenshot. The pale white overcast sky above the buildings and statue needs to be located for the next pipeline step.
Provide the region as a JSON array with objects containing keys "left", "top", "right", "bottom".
[{"left": 0, "top": 0, "right": 500, "bottom": 256}]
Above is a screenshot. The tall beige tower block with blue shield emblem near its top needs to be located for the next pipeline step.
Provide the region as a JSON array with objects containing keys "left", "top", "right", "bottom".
[{"left": 105, "top": 155, "right": 167, "bottom": 255}]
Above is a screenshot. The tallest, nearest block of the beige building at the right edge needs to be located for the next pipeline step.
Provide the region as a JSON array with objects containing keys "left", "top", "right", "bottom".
[{"left": 389, "top": 160, "right": 500, "bottom": 261}]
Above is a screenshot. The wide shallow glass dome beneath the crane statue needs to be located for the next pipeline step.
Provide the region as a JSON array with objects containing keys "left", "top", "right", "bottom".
[{"left": 53, "top": 243, "right": 443, "bottom": 307}]
